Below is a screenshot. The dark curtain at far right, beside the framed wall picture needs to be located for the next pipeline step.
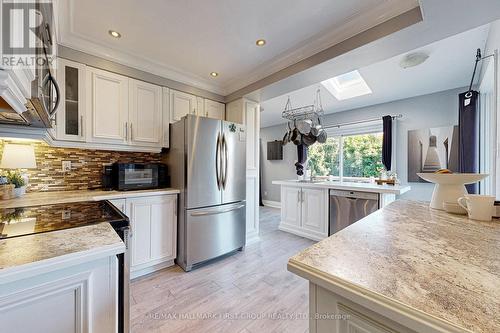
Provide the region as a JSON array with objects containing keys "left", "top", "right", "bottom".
[{"left": 458, "top": 91, "right": 479, "bottom": 193}]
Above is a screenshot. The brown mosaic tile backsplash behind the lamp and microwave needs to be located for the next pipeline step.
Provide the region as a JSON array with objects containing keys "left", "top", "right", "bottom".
[{"left": 0, "top": 140, "right": 162, "bottom": 192}]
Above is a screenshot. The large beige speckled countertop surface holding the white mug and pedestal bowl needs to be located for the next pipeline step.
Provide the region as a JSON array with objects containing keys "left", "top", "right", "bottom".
[{"left": 288, "top": 201, "right": 500, "bottom": 332}]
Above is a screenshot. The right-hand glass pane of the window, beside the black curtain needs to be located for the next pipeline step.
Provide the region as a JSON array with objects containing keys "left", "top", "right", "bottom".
[{"left": 342, "top": 133, "right": 383, "bottom": 178}]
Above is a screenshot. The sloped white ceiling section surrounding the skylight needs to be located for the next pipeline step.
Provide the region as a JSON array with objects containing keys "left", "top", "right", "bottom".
[{"left": 261, "top": 24, "right": 489, "bottom": 127}]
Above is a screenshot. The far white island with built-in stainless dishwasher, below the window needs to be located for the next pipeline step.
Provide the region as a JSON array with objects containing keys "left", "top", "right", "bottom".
[{"left": 273, "top": 180, "right": 411, "bottom": 240}]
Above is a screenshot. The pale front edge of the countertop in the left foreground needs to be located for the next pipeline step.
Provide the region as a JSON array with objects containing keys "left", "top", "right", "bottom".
[{"left": 0, "top": 242, "right": 125, "bottom": 284}]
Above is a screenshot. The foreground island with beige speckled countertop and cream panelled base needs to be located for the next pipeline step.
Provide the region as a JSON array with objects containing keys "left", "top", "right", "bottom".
[{"left": 288, "top": 201, "right": 500, "bottom": 333}]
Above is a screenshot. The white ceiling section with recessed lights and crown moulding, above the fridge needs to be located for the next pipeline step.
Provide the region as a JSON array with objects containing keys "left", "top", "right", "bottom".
[{"left": 57, "top": 0, "right": 418, "bottom": 95}]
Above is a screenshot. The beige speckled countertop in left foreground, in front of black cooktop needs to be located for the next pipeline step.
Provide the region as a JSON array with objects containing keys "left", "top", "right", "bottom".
[{"left": 0, "top": 223, "right": 125, "bottom": 283}]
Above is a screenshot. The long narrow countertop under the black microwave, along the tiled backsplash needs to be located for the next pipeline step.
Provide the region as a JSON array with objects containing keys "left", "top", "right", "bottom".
[{"left": 0, "top": 188, "right": 179, "bottom": 209}]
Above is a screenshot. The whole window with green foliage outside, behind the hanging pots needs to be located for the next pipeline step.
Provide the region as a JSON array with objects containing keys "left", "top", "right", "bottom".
[{"left": 307, "top": 132, "right": 383, "bottom": 180}]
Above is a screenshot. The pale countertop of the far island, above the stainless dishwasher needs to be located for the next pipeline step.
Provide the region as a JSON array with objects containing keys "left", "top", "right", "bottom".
[{"left": 273, "top": 180, "right": 411, "bottom": 195}]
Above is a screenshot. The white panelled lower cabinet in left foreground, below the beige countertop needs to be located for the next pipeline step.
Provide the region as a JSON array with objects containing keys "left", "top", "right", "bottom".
[{"left": 0, "top": 256, "right": 118, "bottom": 333}]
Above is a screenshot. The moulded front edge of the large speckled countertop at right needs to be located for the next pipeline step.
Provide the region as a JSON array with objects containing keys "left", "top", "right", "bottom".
[{"left": 287, "top": 259, "right": 473, "bottom": 333}]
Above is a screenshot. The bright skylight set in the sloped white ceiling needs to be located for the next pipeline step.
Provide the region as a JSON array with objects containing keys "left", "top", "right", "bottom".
[{"left": 321, "top": 70, "right": 372, "bottom": 101}]
